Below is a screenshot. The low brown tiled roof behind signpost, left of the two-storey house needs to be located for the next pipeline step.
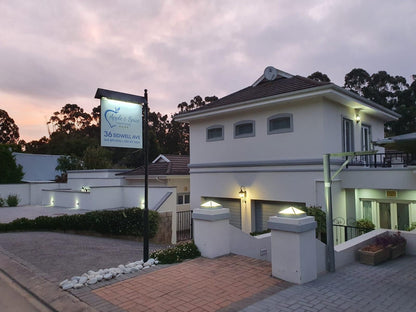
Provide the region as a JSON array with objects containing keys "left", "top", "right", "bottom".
[{"left": 119, "top": 155, "right": 189, "bottom": 177}]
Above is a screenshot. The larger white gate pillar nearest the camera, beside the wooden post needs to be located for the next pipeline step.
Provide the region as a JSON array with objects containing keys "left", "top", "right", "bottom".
[{"left": 268, "top": 216, "right": 317, "bottom": 284}]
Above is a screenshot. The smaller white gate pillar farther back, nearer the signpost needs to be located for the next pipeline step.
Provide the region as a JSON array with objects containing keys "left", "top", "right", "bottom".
[{"left": 192, "top": 208, "right": 230, "bottom": 258}]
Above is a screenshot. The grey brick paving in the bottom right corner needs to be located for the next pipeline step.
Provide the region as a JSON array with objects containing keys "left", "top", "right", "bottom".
[{"left": 242, "top": 256, "right": 416, "bottom": 312}]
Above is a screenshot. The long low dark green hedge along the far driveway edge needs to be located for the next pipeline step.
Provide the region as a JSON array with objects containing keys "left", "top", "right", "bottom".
[{"left": 0, "top": 208, "right": 159, "bottom": 237}]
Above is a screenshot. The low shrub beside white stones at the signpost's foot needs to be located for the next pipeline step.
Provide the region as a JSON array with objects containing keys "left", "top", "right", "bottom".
[{"left": 150, "top": 242, "right": 201, "bottom": 264}]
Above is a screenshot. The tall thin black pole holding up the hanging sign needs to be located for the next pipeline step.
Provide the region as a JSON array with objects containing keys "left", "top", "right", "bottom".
[{"left": 143, "top": 89, "right": 149, "bottom": 262}]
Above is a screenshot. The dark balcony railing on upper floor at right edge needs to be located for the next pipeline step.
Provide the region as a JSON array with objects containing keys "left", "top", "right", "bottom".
[{"left": 347, "top": 152, "right": 416, "bottom": 168}]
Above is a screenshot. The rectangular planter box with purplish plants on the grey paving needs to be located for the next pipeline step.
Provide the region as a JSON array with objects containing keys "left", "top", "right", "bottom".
[{"left": 358, "top": 232, "right": 406, "bottom": 265}]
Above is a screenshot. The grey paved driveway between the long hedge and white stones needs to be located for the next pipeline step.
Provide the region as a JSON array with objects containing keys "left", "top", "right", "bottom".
[{"left": 0, "top": 232, "right": 162, "bottom": 282}]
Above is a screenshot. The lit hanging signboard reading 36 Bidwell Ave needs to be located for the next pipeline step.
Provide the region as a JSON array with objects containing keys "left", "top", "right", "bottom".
[{"left": 101, "top": 97, "right": 143, "bottom": 148}]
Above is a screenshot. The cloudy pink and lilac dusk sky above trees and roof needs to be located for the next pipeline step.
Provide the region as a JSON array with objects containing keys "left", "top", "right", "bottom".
[{"left": 0, "top": 0, "right": 416, "bottom": 141}]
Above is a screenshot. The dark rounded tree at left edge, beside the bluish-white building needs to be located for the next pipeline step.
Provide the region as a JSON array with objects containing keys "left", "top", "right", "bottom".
[{"left": 0, "top": 145, "right": 24, "bottom": 184}]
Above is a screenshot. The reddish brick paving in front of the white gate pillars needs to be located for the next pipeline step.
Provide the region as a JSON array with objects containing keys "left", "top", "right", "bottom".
[{"left": 93, "top": 255, "right": 291, "bottom": 312}]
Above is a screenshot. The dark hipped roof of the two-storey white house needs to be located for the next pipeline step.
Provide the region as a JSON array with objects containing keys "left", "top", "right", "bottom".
[{"left": 174, "top": 70, "right": 400, "bottom": 121}]
